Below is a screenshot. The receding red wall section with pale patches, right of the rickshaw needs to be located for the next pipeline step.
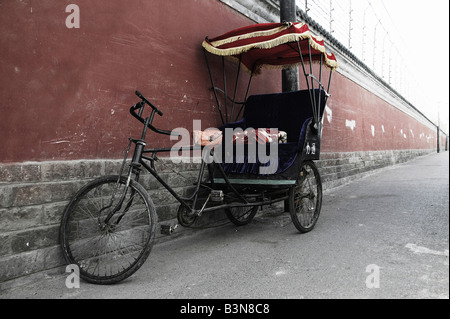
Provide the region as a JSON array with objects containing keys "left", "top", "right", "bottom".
[{"left": 322, "top": 74, "right": 437, "bottom": 152}]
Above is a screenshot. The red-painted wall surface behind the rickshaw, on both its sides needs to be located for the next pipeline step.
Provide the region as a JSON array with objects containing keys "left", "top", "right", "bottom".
[{"left": 0, "top": 0, "right": 436, "bottom": 163}]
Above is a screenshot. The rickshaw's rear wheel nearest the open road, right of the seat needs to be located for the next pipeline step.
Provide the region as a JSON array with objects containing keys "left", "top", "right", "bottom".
[{"left": 289, "top": 161, "right": 322, "bottom": 233}]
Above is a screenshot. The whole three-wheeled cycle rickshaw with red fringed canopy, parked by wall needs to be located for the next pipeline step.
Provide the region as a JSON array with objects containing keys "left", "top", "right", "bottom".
[{"left": 60, "top": 22, "right": 337, "bottom": 284}]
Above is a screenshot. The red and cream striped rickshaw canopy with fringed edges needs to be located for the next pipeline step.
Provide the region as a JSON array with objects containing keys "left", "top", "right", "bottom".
[{"left": 202, "top": 22, "right": 338, "bottom": 73}]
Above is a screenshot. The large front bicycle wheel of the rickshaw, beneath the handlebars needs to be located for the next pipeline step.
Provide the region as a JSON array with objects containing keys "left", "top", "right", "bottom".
[{"left": 60, "top": 175, "right": 157, "bottom": 285}]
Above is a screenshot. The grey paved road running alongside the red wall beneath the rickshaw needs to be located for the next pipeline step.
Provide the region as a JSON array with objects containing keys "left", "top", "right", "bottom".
[{"left": 0, "top": 152, "right": 449, "bottom": 299}]
